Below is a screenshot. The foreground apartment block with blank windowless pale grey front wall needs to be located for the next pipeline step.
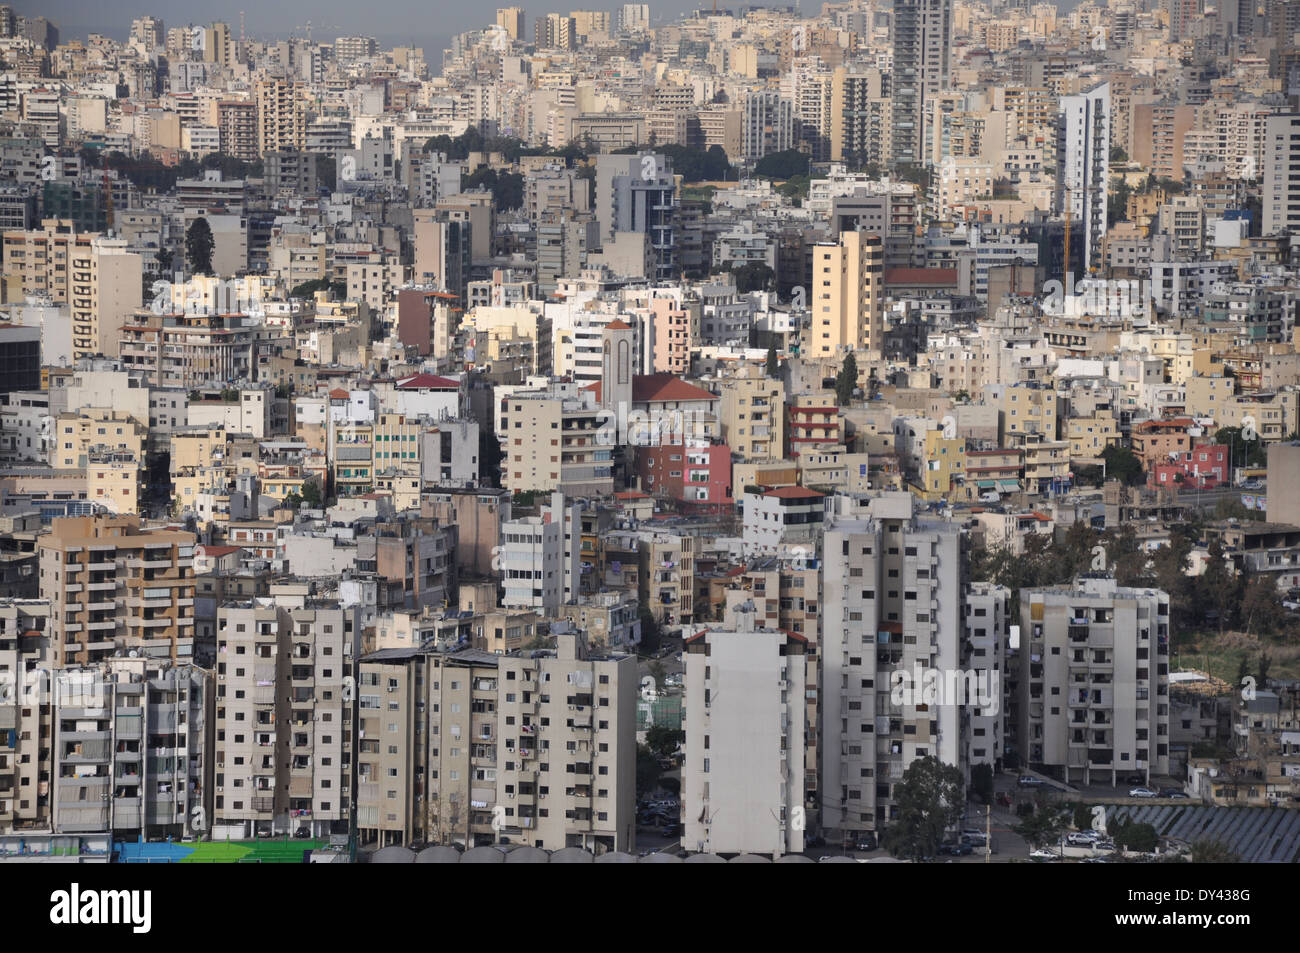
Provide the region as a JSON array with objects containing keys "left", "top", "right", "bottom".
[{"left": 681, "top": 608, "right": 807, "bottom": 855}]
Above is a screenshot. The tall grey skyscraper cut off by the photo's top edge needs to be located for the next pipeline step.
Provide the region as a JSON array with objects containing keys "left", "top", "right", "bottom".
[{"left": 891, "top": 0, "right": 953, "bottom": 165}]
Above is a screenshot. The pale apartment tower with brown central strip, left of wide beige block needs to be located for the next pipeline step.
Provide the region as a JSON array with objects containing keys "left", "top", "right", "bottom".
[{"left": 212, "top": 598, "right": 356, "bottom": 839}]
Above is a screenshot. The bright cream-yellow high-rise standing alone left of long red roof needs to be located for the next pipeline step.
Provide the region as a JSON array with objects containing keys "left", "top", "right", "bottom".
[{"left": 805, "top": 231, "right": 884, "bottom": 358}]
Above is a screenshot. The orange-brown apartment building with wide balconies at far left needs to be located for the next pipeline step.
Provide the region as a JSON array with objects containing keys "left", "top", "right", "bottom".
[{"left": 36, "top": 516, "right": 195, "bottom": 666}]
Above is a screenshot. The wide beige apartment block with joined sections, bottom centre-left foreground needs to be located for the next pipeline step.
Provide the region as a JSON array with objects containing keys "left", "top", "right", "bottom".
[{"left": 358, "top": 634, "right": 637, "bottom": 853}]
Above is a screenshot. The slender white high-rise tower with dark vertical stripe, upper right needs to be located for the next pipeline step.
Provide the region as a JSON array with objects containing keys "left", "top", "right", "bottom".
[{"left": 1056, "top": 83, "right": 1110, "bottom": 273}]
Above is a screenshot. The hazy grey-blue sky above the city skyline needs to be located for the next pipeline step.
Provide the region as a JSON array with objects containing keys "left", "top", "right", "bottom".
[{"left": 9, "top": 0, "right": 722, "bottom": 51}]
